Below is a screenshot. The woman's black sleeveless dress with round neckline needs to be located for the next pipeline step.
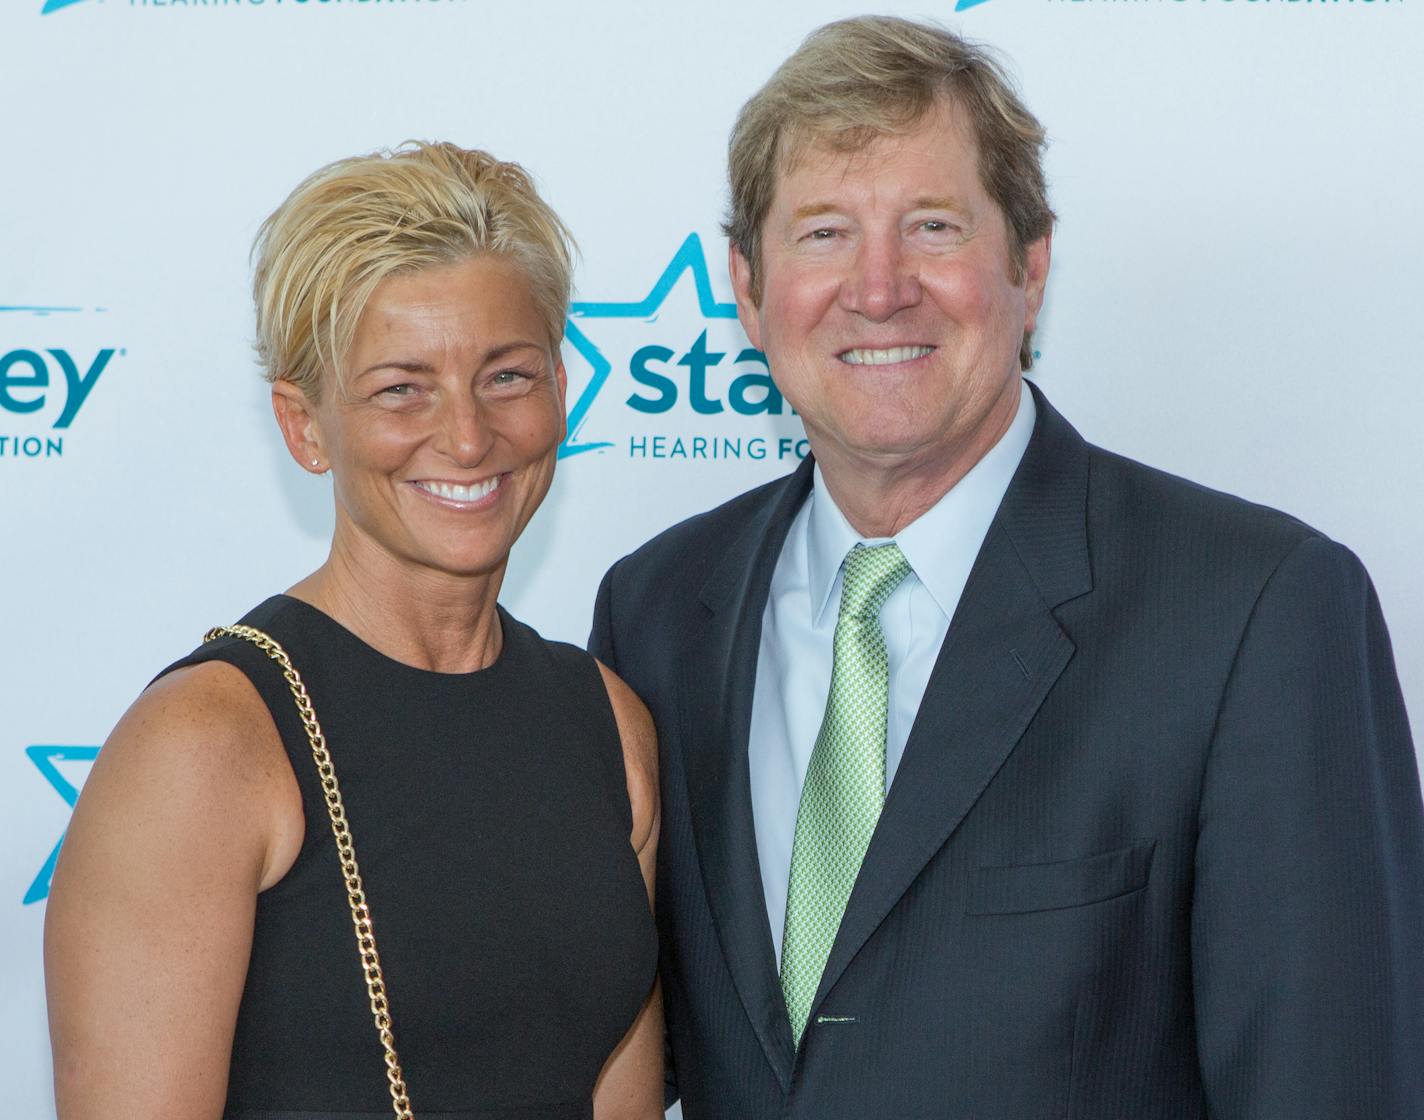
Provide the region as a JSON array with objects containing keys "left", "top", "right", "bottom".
[{"left": 165, "top": 595, "right": 656, "bottom": 1120}]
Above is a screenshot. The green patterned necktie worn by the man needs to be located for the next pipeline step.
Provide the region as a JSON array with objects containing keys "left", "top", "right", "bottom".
[{"left": 782, "top": 545, "right": 910, "bottom": 1046}]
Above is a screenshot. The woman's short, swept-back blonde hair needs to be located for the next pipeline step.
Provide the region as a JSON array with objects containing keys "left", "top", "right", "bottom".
[{"left": 252, "top": 142, "right": 574, "bottom": 401}]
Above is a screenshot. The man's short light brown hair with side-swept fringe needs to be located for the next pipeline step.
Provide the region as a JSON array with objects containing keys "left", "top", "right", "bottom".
[{"left": 723, "top": 16, "right": 1054, "bottom": 370}]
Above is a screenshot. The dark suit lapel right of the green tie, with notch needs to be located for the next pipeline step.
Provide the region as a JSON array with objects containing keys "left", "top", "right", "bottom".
[{"left": 813, "top": 389, "right": 1092, "bottom": 1013}]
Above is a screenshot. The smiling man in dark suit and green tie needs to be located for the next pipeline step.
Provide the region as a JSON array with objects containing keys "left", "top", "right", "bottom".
[{"left": 591, "top": 19, "right": 1424, "bottom": 1120}]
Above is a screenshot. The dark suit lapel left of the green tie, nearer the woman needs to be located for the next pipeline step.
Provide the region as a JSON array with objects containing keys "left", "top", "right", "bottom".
[{"left": 681, "top": 458, "right": 812, "bottom": 1092}]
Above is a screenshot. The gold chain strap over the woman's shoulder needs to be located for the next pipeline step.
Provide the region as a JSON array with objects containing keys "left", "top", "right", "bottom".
[{"left": 202, "top": 626, "right": 414, "bottom": 1120}]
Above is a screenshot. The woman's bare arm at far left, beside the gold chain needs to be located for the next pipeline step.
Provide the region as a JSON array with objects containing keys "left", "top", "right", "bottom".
[{"left": 44, "top": 663, "right": 303, "bottom": 1120}]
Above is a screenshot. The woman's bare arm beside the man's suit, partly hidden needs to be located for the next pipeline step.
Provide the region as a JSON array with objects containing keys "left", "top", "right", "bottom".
[{"left": 594, "top": 665, "right": 662, "bottom": 1120}]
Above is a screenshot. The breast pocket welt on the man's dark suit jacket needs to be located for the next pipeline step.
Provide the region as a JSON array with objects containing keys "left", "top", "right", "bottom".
[{"left": 964, "top": 840, "right": 1156, "bottom": 914}]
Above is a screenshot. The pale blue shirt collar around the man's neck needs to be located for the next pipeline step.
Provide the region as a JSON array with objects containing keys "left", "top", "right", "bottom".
[{"left": 806, "top": 384, "right": 1037, "bottom": 625}]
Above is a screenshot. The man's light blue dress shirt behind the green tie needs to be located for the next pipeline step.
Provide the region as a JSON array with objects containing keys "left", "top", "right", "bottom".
[{"left": 748, "top": 386, "right": 1034, "bottom": 968}]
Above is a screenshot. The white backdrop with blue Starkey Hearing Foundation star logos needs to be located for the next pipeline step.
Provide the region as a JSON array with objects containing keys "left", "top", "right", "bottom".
[{"left": 0, "top": 0, "right": 1424, "bottom": 1120}]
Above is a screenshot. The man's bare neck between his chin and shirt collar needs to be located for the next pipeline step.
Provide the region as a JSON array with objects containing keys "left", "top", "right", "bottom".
[{"left": 807, "top": 381, "right": 1024, "bottom": 539}]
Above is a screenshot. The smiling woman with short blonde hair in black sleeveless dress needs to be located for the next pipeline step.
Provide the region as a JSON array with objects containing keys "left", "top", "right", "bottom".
[{"left": 46, "top": 144, "right": 662, "bottom": 1120}]
